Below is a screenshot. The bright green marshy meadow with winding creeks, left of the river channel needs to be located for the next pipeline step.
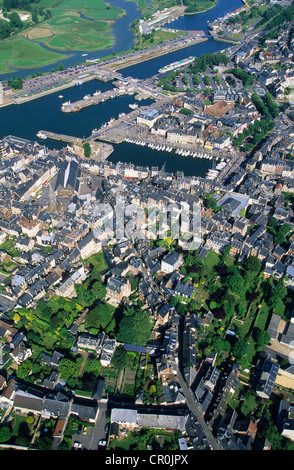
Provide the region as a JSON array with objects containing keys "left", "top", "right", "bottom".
[{"left": 0, "top": 0, "right": 125, "bottom": 73}]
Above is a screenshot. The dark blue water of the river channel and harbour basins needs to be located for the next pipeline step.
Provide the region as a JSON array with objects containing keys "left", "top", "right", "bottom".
[{"left": 0, "top": 0, "right": 243, "bottom": 176}]
